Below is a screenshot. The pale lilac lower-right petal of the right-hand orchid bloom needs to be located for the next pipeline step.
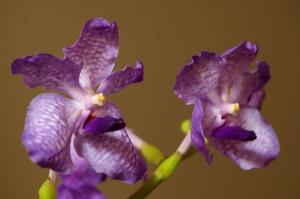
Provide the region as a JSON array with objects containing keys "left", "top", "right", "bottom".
[{"left": 210, "top": 107, "right": 280, "bottom": 170}]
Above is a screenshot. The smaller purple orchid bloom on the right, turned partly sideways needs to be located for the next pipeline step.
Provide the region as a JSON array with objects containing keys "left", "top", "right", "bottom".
[{"left": 174, "top": 42, "right": 280, "bottom": 170}]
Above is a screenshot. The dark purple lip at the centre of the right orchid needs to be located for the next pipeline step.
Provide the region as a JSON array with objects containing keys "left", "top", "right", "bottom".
[{"left": 212, "top": 125, "right": 256, "bottom": 141}]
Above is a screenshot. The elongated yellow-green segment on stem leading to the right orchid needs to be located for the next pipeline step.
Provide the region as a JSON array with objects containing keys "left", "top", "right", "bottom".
[{"left": 154, "top": 152, "right": 182, "bottom": 180}]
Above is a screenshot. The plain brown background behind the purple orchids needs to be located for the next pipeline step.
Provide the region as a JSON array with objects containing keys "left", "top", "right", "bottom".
[{"left": 0, "top": 0, "right": 300, "bottom": 199}]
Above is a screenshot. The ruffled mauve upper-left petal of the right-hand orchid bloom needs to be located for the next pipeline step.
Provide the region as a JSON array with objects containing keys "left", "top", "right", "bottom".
[{"left": 173, "top": 52, "right": 224, "bottom": 104}]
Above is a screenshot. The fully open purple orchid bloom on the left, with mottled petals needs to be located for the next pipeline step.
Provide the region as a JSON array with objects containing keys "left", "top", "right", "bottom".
[{"left": 11, "top": 18, "right": 146, "bottom": 183}]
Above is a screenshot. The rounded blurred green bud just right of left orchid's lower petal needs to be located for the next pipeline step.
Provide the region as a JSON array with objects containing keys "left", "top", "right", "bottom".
[{"left": 141, "top": 143, "right": 165, "bottom": 165}]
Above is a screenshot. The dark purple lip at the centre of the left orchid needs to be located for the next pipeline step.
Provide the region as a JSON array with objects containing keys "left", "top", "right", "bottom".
[{"left": 83, "top": 116, "right": 126, "bottom": 134}]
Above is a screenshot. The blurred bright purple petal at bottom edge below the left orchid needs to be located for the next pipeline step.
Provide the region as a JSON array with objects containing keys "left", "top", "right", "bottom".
[{"left": 57, "top": 184, "right": 105, "bottom": 199}]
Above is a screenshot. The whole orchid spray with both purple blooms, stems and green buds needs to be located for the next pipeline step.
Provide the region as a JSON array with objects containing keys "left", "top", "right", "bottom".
[{"left": 11, "top": 18, "right": 280, "bottom": 199}]
